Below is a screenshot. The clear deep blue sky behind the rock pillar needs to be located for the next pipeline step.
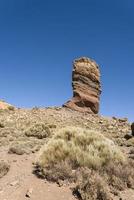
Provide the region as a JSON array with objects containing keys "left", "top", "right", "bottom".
[{"left": 0, "top": 0, "right": 134, "bottom": 120}]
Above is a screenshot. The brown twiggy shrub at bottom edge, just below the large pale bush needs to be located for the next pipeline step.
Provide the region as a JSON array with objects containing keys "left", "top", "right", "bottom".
[{"left": 73, "top": 168, "right": 112, "bottom": 200}]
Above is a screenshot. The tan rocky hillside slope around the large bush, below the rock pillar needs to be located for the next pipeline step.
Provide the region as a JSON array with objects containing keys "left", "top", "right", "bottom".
[{"left": 0, "top": 107, "right": 134, "bottom": 200}]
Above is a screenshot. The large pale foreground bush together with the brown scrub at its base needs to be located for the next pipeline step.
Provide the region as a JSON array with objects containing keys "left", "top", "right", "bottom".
[{"left": 35, "top": 127, "right": 134, "bottom": 200}]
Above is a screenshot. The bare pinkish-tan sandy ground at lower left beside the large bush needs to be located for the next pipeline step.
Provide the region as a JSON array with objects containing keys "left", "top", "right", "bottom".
[{"left": 0, "top": 152, "right": 75, "bottom": 200}]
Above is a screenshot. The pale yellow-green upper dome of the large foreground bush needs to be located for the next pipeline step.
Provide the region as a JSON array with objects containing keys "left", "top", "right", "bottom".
[{"left": 38, "top": 127, "right": 125, "bottom": 169}]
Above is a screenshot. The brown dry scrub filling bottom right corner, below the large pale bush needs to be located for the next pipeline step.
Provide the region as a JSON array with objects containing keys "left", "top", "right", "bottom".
[{"left": 74, "top": 160, "right": 134, "bottom": 200}]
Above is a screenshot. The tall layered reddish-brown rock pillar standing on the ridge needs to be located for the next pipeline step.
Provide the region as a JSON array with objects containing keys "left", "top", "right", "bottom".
[{"left": 63, "top": 57, "right": 101, "bottom": 114}]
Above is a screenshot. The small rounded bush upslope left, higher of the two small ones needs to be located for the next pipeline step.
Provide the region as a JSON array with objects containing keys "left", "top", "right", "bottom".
[{"left": 25, "top": 123, "right": 51, "bottom": 139}]
